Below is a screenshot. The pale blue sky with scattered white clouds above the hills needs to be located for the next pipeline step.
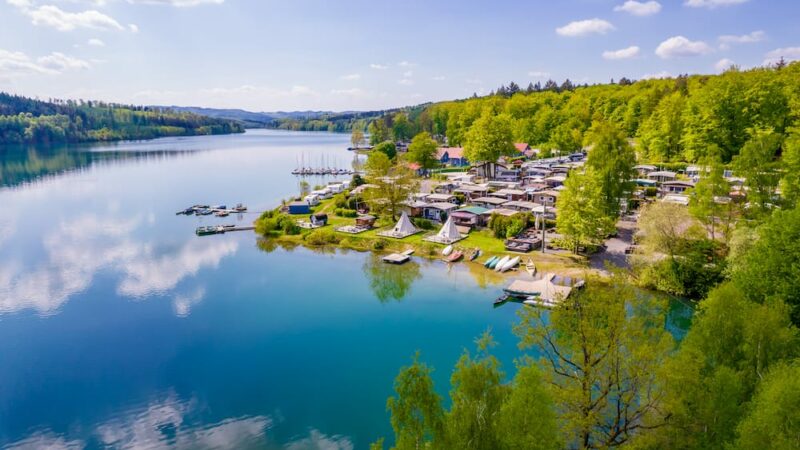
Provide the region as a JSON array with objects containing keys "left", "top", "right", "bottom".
[{"left": 0, "top": 0, "right": 800, "bottom": 111}]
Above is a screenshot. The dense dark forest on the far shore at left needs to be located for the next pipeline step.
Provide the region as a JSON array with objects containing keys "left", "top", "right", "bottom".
[{"left": 0, "top": 93, "right": 243, "bottom": 144}]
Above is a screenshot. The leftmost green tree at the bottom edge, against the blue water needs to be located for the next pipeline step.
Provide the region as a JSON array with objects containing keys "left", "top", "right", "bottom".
[{"left": 386, "top": 353, "right": 444, "bottom": 450}]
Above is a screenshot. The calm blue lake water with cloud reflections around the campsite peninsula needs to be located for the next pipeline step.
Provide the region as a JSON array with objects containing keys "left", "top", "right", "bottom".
[{"left": 0, "top": 131, "right": 688, "bottom": 449}]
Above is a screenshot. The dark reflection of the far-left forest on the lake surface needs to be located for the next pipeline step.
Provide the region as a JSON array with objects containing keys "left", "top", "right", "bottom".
[{"left": 0, "top": 146, "right": 191, "bottom": 187}]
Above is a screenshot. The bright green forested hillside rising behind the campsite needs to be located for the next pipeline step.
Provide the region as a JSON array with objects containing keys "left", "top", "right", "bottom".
[{"left": 370, "top": 63, "right": 800, "bottom": 162}]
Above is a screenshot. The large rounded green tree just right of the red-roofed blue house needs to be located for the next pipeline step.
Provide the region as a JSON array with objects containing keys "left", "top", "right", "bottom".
[{"left": 464, "top": 111, "right": 516, "bottom": 162}]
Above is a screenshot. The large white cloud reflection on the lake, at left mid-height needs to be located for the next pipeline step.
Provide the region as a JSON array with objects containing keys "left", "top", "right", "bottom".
[{"left": 0, "top": 214, "right": 238, "bottom": 315}]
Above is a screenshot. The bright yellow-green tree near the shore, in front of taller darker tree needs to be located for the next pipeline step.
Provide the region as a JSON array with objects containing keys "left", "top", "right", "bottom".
[{"left": 556, "top": 170, "right": 615, "bottom": 253}]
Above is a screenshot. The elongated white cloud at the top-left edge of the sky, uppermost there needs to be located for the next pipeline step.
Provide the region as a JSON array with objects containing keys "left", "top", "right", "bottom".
[{"left": 6, "top": 0, "right": 125, "bottom": 31}]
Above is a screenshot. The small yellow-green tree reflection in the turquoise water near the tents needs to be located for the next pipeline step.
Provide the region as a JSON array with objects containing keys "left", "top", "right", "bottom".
[{"left": 363, "top": 253, "right": 421, "bottom": 303}]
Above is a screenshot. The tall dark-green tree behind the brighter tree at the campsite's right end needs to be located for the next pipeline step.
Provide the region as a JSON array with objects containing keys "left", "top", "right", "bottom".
[{"left": 586, "top": 121, "right": 636, "bottom": 217}]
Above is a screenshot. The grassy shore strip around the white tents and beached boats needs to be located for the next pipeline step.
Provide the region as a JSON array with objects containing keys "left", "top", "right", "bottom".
[{"left": 255, "top": 200, "right": 588, "bottom": 276}]
